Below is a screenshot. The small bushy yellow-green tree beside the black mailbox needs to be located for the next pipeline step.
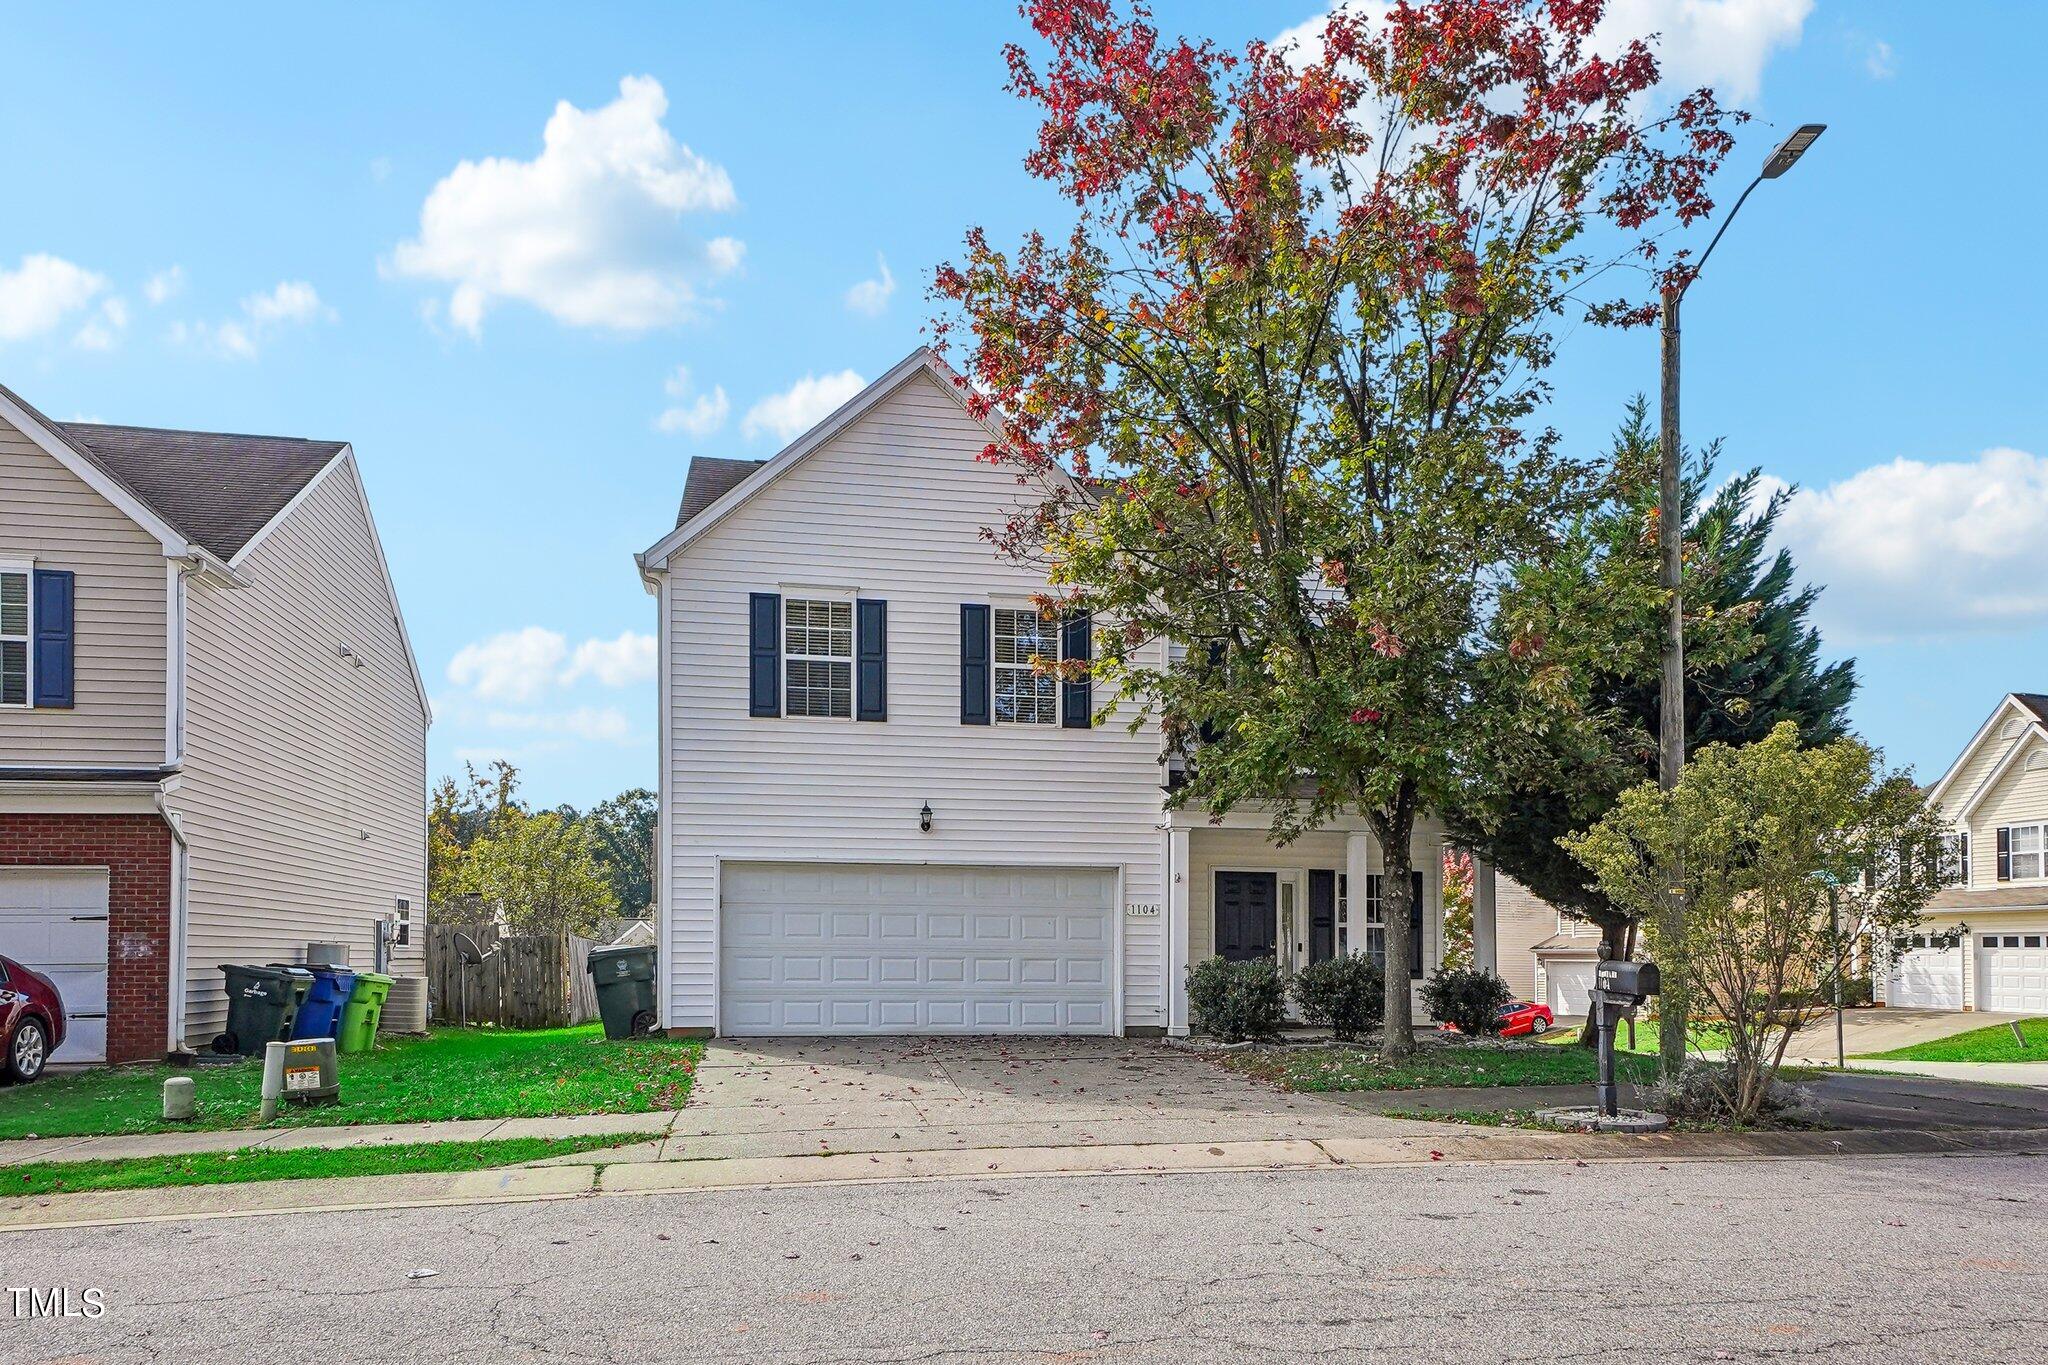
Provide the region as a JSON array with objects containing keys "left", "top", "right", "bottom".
[{"left": 1565, "top": 722, "right": 1942, "bottom": 1124}]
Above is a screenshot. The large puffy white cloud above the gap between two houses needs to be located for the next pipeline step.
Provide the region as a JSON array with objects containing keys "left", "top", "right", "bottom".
[{"left": 385, "top": 76, "right": 743, "bottom": 336}]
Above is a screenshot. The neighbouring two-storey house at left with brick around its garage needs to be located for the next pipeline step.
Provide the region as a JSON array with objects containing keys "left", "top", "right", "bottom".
[{"left": 0, "top": 378, "right": 428, "bottom": 1062}]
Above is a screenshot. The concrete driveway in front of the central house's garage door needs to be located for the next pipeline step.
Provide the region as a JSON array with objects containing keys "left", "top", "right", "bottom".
[{"left": 664, "top": 1038, "right": 1454, "bottom": 1158}]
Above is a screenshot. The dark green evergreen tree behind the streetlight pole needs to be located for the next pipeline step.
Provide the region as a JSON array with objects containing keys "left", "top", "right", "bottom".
[{"left": 1452, "top": 399, "right": 1855, "bottom": 1046}]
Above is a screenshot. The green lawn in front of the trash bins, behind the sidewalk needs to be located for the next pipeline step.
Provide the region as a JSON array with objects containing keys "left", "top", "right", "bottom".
[{"left": 0, "top": 1023, "right": 705, "bottom": 1138}]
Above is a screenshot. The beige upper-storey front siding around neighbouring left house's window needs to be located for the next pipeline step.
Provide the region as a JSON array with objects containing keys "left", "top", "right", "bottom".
[{"left": 0, "top": 420, "right": 168, "bottom": 767}]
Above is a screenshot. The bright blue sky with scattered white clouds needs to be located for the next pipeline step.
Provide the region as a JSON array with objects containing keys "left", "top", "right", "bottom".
[{"left": 0, "top": 0, "right": 2048, "bottom": 804}]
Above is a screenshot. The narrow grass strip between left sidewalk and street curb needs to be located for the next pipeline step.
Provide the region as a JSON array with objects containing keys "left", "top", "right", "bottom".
[{"left": 0, "top": 1134, "right": 647, "bottom": 1195}]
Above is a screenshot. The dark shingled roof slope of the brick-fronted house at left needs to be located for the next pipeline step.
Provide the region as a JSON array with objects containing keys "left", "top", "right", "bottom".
[{"left": 57, "top": 422, "right": 346, "bottom": 561}]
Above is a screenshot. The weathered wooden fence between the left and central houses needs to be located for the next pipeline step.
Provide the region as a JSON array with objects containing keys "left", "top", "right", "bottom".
[{"left": 426, "top": 921, "right": 598, "bottom": 1029}]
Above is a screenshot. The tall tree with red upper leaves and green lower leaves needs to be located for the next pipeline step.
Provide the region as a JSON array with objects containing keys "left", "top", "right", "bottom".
[{"left": 934, "top": 0, "right": 1741, "bottom": 1056}]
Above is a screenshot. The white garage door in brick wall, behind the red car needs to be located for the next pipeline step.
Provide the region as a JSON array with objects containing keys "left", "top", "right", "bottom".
[{"left": 0, "top": 868, "right": 106, "bottom": 1062}]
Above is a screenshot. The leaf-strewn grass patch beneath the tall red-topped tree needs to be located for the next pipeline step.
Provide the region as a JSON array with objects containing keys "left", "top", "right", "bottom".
[{"left": 1223, "top": 1044, "right": 1657, "bottom": 1091}]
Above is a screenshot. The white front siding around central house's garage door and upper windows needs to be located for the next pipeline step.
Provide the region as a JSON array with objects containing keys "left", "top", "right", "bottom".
[{"left": 662, "top": 372, "right": 1165, "bottom": 1027}]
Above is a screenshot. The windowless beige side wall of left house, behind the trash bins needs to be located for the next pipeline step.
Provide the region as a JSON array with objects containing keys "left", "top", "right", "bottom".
[{"left": 170, "top": 458, "right": 426, "bottom": 1044}]
